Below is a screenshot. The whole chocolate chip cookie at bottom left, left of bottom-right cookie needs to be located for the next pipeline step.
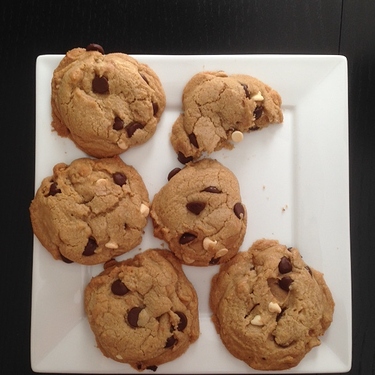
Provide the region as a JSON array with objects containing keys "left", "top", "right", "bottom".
[{"left": 84, "top": 249, "right": 199, "bottom": 371}]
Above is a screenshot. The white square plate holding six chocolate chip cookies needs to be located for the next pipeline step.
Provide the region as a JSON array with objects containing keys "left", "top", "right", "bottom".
[{"left": 31, "top": 55, "right": 352, "bottom": 374}]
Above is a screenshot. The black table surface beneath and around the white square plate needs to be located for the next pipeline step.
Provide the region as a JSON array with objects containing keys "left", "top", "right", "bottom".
[{"left": 0, "top": 0, "right": 375, "bottom": 375}]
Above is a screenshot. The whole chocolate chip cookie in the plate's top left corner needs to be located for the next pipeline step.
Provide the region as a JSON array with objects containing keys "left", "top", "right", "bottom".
[{"left": 51, "top": 45, "right": 166, "bottom": 158}]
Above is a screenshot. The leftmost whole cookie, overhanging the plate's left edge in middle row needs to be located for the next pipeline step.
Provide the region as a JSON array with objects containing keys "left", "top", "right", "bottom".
[{"left": 30, "top": 156, "right": 150, "bottom": 265}]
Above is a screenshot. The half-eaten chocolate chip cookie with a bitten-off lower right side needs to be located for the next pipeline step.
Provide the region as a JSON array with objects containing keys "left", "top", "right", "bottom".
[{"left": 170, "top": 71, "right": 283, "bottom": 164}]
